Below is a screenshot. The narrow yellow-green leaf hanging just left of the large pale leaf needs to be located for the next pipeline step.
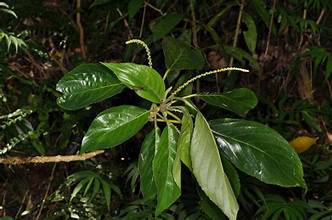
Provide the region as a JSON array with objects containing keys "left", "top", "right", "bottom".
[{"left": 177, "top": 109, "right": 194, "bottom": 170}]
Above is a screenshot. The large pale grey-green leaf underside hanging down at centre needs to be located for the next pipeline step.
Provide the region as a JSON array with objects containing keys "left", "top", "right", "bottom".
[{"left": 190, "top": 113, "right": 239, "bottom": 220}]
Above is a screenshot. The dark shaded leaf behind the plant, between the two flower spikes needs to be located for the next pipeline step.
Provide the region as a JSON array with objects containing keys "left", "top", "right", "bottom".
[{"left": 162, "top": 37, "right": 205, "bottom": 70}]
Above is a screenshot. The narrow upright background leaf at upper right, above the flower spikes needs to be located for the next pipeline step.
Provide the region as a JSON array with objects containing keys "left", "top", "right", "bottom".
[{"left": 243, "top": 13, "right": 257, "bottom": 54}]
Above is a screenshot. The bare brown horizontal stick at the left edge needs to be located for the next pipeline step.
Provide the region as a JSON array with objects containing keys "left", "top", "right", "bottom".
[{"left": 0, "top": 150, "right": 104, "bottom": 165}]
